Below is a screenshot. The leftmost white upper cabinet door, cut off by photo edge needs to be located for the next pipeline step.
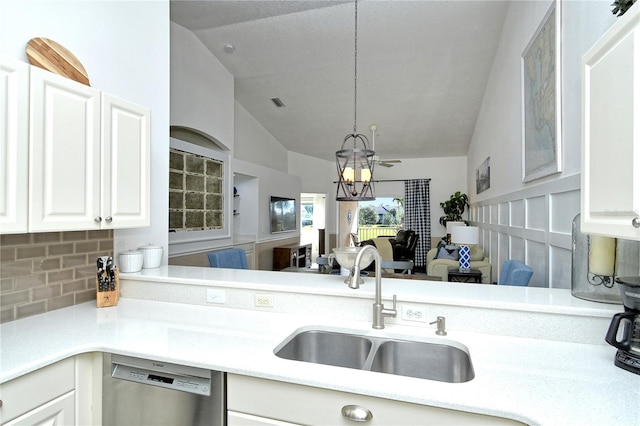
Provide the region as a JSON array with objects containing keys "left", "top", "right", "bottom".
[{"left": 0, "top": 57, "right": 29, "bottom": 234}]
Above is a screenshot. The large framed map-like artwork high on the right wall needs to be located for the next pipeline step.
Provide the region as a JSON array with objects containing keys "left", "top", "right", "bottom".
[{"left": 521, "top": 0, "right": 562, "bottom": 182}]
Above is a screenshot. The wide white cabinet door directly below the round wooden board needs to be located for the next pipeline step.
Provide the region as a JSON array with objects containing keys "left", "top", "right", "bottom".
[{"left": 29, "top": 67, "right": 100, "bottom": 232}]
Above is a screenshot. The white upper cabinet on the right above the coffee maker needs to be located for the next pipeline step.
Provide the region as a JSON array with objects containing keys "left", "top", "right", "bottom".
[{"left": 581, "top": 5, "right": 640, "bottom": 240}]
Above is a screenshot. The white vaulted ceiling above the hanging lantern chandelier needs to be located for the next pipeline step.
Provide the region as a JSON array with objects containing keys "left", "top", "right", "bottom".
[{"left": 171, "top": 0, "right": 509, "bottom": 161}]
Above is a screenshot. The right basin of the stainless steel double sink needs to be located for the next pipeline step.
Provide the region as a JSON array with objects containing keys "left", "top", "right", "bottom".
[{"left": 364, "top": 340, "right": 475, "bottom": 383}]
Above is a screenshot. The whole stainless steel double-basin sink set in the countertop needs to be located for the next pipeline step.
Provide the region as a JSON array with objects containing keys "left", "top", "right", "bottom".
[{"left": 274, "top": 329, "right": 475, "bottom": 383}]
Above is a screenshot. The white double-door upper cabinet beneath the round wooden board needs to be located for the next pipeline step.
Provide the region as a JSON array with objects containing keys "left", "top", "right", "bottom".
[{"left": 29, "top": 67, "right": 151, "bottom": 232}]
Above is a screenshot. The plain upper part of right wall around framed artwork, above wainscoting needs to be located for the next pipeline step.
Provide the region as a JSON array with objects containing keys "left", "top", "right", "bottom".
[{"left": 467, "top": 0, "right": 615, "bottom": 202}]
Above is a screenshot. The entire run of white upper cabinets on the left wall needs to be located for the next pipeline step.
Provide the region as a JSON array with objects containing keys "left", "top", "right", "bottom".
[{"left": 0, "top": 57, "right": 151, "bottom": 234}]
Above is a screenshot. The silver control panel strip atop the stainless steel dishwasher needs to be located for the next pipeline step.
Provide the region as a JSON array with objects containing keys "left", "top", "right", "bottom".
[{"left": 111, "top": 355, "right": 211, "bottom": 396}]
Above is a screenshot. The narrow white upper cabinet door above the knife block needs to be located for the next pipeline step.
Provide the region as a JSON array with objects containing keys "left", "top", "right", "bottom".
[{"left": 102, "top": 93, "right": 151, "bottom": 228}]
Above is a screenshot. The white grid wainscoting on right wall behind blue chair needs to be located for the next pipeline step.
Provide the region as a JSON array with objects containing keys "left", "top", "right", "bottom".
[{"left": 471, "top": 174, "right": 580, "bottom": 288}]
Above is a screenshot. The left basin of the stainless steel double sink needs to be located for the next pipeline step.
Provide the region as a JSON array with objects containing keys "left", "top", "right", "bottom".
[{"left": 276, "top": 330, "right": 372, "bottom": 368}]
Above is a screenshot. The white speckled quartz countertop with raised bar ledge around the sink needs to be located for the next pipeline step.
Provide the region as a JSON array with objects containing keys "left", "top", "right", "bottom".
[{"left": 0, "top": 266, "right": 640, "bottom": 425}]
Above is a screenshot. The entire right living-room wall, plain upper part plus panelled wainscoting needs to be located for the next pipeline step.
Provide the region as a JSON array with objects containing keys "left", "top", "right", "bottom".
[{"left": 467, "top": 0, "right": 615, "bottom": 288}]
